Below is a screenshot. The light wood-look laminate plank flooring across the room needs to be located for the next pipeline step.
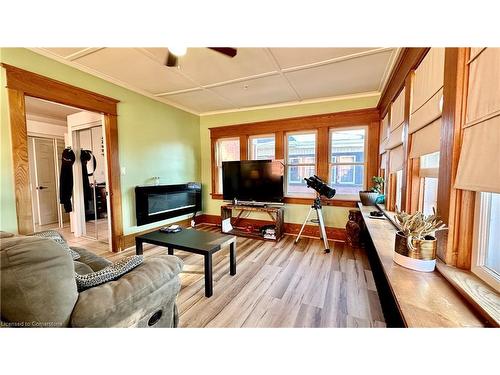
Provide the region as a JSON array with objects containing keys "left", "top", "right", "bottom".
[{"left": 59, "top": 224, "right": 385, "bottom": 327}]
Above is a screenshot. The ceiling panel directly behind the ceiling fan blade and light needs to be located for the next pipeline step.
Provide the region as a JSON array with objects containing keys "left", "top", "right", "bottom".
[{"left": 175, "top": 48, "right": 276, "bottom": 85}]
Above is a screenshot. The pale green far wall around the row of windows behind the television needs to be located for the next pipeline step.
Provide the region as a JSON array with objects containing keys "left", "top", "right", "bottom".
[{"left": 200, "top": 95, "right": 379, "bottom": 228}]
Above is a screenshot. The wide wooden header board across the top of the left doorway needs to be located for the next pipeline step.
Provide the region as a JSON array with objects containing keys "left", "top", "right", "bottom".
[{"left": 0, "top": 63, "right": 119, "bottom": 115}]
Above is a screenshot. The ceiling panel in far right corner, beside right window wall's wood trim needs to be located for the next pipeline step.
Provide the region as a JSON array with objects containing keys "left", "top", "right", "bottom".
[{"left": 285, "top": 51, "right": 392, "bottom": 99}]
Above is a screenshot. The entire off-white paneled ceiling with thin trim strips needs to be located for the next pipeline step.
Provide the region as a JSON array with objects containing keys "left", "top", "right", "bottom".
[{"left": 34, "top": 48, "right": 399, "bottom": 114}]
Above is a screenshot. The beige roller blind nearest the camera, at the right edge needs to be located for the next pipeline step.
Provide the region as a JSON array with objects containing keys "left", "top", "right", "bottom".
[{"left": 455, "top": 48, "right": 500, "bottom": 193}]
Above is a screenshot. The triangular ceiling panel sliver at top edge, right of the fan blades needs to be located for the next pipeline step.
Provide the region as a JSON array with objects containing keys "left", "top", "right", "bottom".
[{"left": 270, "top": 48, "right": 375, "bottom": 69}]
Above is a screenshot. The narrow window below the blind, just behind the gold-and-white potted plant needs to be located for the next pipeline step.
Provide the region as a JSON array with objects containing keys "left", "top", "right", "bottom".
[{"left": 419, "top": 151, "right": 439, "bottom": 215}]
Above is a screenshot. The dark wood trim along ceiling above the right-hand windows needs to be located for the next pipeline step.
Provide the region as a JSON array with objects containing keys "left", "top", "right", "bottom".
[{"left": 377, "top": 47, "right": 430, "bottom": 118}]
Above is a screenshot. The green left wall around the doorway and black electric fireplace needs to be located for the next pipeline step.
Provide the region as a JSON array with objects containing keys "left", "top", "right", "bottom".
[{"left": 0, "top": 48, "right": 200, "bottom": 234}]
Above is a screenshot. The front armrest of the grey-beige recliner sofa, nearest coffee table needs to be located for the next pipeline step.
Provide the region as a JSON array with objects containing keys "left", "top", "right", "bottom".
[{"left": 71, "top": 255, "right": 183, "bottom": 327}]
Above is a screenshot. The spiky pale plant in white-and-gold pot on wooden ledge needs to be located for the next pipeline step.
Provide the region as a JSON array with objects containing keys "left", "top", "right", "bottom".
[{"left": 393, "top": 210, "right": 447, "bottom": 272}]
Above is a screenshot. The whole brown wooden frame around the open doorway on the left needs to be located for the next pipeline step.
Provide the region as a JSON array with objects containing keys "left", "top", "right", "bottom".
[{"left": 1, "top": 64, "right": 123, "bottom": 252}]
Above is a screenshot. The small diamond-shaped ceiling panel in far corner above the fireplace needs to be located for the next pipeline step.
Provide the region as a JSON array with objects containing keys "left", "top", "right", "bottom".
[{"left": 161, "top": 90, "right": 234, "bottom": 112}]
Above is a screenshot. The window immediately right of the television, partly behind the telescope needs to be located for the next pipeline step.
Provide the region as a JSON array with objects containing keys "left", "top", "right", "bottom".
[{"left": 285, "top": 132, "right": 316, "bottom": 196}]
